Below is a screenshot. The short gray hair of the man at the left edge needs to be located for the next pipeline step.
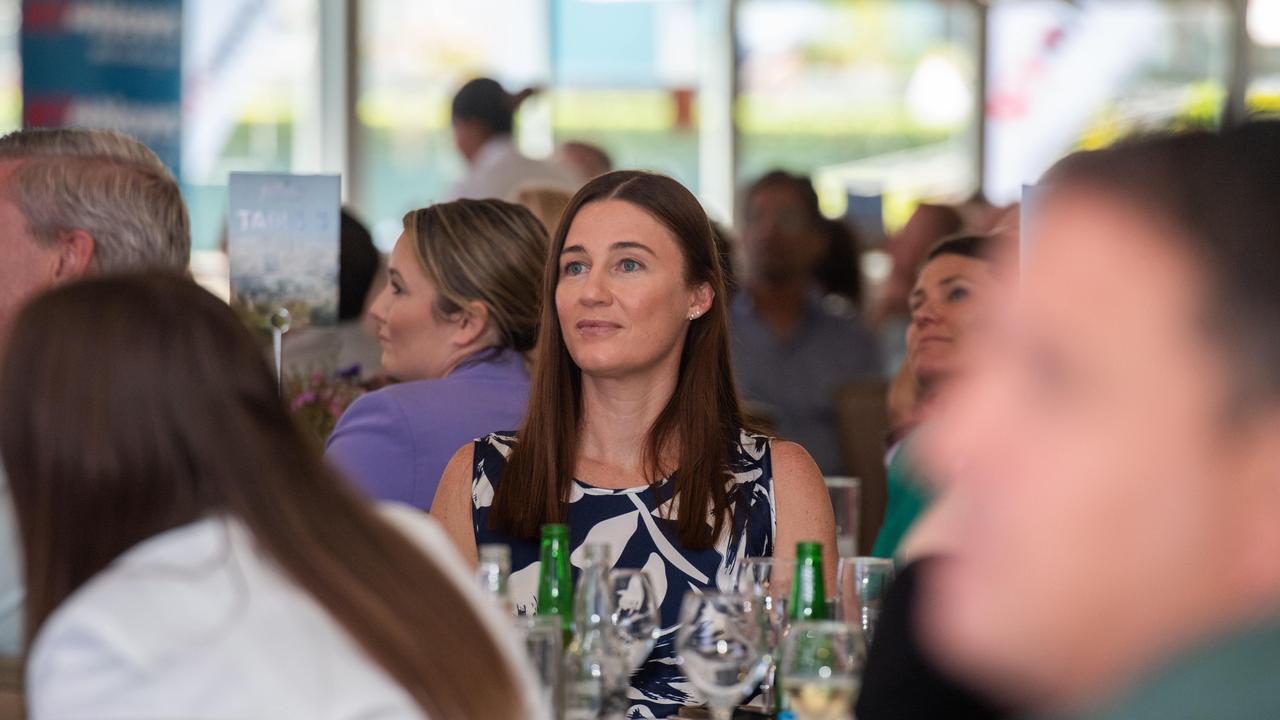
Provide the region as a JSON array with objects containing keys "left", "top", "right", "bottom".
[{"left": 0, "top": 128, "right": 191, "bottom": 272}]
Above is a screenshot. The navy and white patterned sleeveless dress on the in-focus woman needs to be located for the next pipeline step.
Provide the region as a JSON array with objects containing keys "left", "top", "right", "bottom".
[{"left": 471, "top": 432, "right": 777, "bottom": 717}]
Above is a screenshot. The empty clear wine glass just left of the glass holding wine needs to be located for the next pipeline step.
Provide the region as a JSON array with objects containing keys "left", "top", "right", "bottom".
[{"left": 676, "top": 591, "right": 767, "bottom": 720}]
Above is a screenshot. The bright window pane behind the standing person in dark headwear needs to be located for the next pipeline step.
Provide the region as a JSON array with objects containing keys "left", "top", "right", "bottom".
[{"left": 353, "top": 0, "right": 550, "bottom": 250}]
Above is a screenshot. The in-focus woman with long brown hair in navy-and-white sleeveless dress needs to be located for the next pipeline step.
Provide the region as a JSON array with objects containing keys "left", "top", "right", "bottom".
[{"left": 433, "top": 172, "right": 835, "bottom": 717}]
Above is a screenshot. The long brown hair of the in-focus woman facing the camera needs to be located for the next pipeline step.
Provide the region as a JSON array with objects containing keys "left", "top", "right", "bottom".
[{"left": 489, "top": 170, "right": 745, "bottom": 548}]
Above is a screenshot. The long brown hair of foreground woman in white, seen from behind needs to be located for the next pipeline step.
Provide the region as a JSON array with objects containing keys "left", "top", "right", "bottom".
[{"left": 0, "top": 275, "right": 521, "bottom": 717}]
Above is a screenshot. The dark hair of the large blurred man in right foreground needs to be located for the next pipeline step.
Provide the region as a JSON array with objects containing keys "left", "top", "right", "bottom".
[{"left": 1030, "top": 120, "right": 1280, "bottom": 406}]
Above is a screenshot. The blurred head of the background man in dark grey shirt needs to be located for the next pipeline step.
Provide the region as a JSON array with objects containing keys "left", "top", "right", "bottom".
[{"left": 742, "top": 170, "right": 828, "bottom": 286}]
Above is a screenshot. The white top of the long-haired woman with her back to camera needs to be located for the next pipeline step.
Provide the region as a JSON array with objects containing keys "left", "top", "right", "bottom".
[{"left": 26, "top": 506, "right": 545, "bottom": 720}]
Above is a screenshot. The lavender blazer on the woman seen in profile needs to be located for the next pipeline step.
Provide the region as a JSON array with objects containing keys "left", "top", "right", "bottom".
[{"left": 325, "top": 350, "right": 529, "bottom": 510}]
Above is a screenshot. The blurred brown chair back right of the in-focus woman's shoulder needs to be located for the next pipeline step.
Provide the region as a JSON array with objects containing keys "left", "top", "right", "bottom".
[{"left": 835, "top": 379, "right": 888, "bottom": 555}]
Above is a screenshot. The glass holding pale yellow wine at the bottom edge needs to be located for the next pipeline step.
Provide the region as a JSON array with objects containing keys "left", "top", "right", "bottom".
[{"left": 778, "top": 620, "right": 865, "bottom": 720}]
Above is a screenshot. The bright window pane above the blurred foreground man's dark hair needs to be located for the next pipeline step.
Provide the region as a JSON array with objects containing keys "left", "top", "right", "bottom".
[{"left": 986, "top": 0, "right": 1230, "bottom": 202}]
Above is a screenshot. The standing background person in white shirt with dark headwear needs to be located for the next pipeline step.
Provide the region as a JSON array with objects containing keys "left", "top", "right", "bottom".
[{"left": 448, "top": 78, "right": 580, "bottom": 201}]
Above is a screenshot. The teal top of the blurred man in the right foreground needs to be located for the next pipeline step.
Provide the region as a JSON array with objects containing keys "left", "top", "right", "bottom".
[{"left": 1044, "top": 616, "right": 1280, "bottom": 720}]
